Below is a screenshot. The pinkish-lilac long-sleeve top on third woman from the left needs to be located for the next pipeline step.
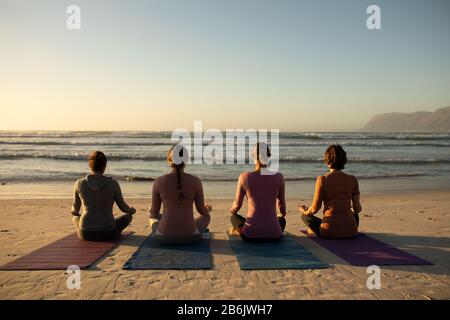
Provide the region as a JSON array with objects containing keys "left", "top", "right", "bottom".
[{"left": 230, "top": 171, "right": 286, "bottom": 238}]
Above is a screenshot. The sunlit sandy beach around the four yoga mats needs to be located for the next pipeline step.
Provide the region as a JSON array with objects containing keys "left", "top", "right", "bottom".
[{"left": 0, "top": 192, "right": 450, "bottom": 300}]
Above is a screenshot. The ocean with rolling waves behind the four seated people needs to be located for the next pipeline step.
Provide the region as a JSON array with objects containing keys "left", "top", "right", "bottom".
[{"left": 0, "top": 131, "right": 450, "bottom": 199}]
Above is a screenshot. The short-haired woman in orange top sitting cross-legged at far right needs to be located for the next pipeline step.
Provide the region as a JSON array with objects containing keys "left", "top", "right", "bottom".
[{"left": 298, "top": 145, "right": 362, "bottom": 239}]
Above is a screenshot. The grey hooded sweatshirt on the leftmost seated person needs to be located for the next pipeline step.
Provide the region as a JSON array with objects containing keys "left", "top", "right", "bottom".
[{"left": 72, "top": 174, "right": 131, "bottom": 231}]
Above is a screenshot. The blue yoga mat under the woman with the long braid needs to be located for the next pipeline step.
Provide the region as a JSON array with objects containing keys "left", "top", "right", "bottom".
[{"left": 123, "top": 232, "right": 212, "bottom": 270}]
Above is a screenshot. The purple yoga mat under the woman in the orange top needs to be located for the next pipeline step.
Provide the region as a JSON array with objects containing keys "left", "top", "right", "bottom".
[{"left": 302, "top": 230, "right": 432, "bottom": 266}]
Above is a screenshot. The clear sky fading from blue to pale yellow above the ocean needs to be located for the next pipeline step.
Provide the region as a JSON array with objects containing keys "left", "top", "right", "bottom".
[{"left": 0, "top": 0, "right": 450, "bottom": 131}]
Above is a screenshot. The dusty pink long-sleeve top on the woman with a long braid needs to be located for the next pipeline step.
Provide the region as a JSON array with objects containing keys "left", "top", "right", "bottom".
[{"left": 150, "top": 172, "right": 209, "bottom": 236}]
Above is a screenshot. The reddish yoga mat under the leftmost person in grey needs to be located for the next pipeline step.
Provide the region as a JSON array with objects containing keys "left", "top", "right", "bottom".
[{"left": 0, "top": 232, "right": 132, "bottom": 270}]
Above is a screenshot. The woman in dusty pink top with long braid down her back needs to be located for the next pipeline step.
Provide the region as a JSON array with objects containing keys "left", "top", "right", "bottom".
[{"left": 150, "top": 144, "right": 212, "bottom": 244}]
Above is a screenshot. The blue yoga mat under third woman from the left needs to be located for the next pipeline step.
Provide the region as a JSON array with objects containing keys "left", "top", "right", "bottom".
[{"left": 228, "top": 233, "right": 330, "bottom": 270}]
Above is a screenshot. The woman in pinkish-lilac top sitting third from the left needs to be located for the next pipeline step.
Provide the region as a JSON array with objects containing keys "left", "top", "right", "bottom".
[{"left": 230, "top": 142, "right": 286, "bottom": 241}]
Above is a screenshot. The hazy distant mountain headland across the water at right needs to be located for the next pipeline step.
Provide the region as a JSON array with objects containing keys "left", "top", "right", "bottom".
[{"left": 361, "top": 106, "right": 450, "bottom": 132}]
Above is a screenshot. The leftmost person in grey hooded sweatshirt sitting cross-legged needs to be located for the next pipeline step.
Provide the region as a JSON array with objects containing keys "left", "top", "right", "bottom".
[{"left": 72, "top": 151, "right": 136, "bottom": 241}]
